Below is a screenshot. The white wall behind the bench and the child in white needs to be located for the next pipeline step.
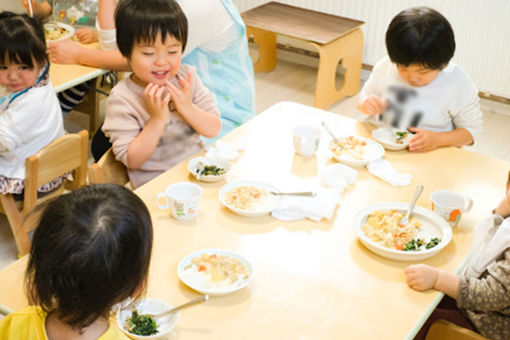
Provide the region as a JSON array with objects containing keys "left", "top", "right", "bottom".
[{"left": 232, "top": 0, "right": 510, "bottom": 98}]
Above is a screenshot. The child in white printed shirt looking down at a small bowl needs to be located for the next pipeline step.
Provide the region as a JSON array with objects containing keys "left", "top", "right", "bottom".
[{"left": 357, "top": 7, "right": 483, "bottom": 152}]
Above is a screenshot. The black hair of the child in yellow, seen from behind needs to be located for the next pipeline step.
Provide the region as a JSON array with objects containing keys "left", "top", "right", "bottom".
[{"left": 25, "top": 184, "right": 152, "bottom": 330}]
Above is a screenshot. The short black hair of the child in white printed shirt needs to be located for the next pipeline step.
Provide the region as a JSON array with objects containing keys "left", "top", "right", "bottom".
[{"left": 386, "top": 7, "right": 455, "bottom": 70}]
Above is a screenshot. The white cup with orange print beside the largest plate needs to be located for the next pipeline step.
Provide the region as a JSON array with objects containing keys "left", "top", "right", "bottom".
[{"left": 430, "top": 190, "right": 473, "bottom": 227}]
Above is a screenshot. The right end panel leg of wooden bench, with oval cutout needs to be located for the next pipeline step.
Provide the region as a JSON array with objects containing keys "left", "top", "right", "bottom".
[{"left": 310, "top": 29, "right": 363, "bottom": 109}]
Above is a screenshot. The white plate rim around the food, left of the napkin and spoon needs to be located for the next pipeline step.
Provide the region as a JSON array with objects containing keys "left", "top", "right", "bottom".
[{"left": 218, "top": 181, "right": 283, "bottom": 217}]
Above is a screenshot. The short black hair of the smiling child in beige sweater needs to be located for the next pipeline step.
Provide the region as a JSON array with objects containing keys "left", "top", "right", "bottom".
[{"left": 115, "top": 0, "right": 188, "bottom": 59}]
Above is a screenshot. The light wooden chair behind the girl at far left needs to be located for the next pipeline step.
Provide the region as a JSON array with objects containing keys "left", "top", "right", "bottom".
[{"left": 0, "top": 130, "right": 89, "bottom": 255}]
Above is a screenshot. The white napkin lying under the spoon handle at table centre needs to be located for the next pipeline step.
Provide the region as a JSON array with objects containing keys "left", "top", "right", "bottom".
[{"left": 271, "top": 188, "right": 340, "bottom": 222}]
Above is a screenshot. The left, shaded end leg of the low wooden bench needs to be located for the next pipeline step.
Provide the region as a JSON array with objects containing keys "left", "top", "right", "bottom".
[{"left": 246, "top": 26, "right": 276, "bottom": 73}]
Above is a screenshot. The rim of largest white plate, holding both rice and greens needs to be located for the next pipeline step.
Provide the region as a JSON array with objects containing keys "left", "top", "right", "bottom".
[{"left": 354, "top": 202, "right": 452, "bottom": 261}]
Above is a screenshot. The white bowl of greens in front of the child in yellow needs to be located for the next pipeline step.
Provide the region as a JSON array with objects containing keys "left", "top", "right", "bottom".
[{"left": 117, "top": 298, "right": 179, "bottom": 340}]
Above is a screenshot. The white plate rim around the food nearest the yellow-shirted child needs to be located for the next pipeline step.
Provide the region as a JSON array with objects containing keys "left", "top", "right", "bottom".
[{"left": 177, "top": 249, "right": 253, "bottom": 296}]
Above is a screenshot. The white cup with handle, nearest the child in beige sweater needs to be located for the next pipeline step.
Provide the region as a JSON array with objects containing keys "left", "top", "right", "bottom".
[{"left": 156, "top": 182, "right": 204, "bottom": 220}]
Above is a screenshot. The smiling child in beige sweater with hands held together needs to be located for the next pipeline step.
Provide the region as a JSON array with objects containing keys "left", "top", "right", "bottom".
[{"left": 102, "top": 0, "right": 221, "bottom": 188}]
